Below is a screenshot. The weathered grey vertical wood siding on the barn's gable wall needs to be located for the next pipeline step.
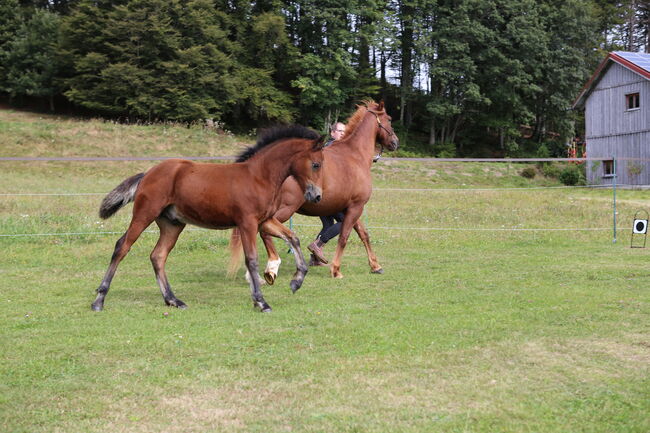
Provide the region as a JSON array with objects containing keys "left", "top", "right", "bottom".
[{"left": 585, "top": 63, "right": 650, "bottom": 185}]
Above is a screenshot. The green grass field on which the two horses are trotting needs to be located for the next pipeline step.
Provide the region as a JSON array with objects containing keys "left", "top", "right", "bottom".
[{"left": 0, "top": 112, "right": 650, "bottom": 433}]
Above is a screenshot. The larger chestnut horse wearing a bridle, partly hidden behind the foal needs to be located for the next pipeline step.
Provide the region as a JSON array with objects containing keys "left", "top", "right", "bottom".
[{"left": 231, "top": 101, "right": 399, "bottom": 284}]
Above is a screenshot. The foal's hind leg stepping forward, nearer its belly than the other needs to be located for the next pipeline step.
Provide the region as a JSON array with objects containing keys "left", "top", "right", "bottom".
[{"left": 151, "top": 217, "right": 187, "bottom": 309}]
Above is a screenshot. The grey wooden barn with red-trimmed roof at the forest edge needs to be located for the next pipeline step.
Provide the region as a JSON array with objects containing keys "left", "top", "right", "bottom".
[{"left": 573, "top": 51, "right": 650, "bottom": 185}]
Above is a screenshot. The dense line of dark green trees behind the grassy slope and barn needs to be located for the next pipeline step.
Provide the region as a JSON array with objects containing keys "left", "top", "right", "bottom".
[{"left": 0, "top": 0, "right": 650, "bottom": 156}]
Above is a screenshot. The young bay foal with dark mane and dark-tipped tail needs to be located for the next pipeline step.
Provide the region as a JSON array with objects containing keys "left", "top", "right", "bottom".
[{"left": 92, "top": 126, "right": 323, "bottom": 312}]
